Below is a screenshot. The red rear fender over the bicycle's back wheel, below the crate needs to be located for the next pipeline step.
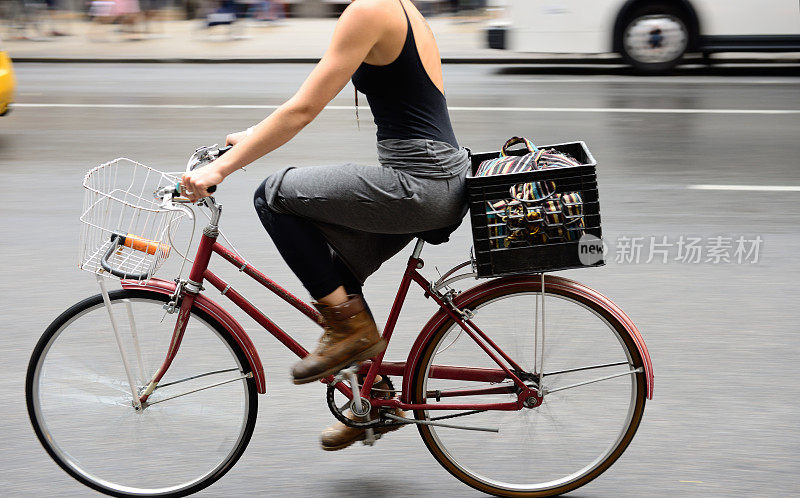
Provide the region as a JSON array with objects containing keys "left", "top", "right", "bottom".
[{"left": 402, "top": 275, "right": 654, "bottom": 403}]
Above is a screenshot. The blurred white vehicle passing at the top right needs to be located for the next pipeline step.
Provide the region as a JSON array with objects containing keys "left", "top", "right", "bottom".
[{"left": 488, "top": 0, "right": 800, "bottom": 72}]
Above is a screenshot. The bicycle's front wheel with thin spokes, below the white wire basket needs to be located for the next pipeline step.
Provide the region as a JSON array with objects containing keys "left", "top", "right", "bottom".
[{"left": 26, "top": 290, "right": 258, "bottom": 496}]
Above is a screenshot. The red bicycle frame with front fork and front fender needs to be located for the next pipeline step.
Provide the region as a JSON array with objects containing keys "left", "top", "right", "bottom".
[{"left": 136, "top": 220, "right": 541, "bottom": 411}]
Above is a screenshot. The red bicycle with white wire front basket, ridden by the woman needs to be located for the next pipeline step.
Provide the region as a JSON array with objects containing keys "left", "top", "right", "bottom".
[{"left": 26, "top": 147, "right": 653, "bottom": 497}]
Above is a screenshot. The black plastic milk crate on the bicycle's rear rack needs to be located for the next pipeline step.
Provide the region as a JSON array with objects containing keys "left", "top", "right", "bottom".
[{"left": 467, "top": 142, "right": 605, "bottom": 277}]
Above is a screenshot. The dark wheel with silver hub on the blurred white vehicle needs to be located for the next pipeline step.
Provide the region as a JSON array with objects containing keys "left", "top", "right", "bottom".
[{"left": 616, "top": 2, "right": 692, "bottom": 74}]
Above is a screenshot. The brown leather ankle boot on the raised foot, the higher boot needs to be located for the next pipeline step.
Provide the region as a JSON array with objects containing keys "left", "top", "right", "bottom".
[{"left": 292, "top": 295, "right": 386, "bottom": 384}]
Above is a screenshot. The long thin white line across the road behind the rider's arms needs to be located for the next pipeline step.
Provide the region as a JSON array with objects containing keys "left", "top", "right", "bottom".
[{"left": 14, "top": 102, "right": 800, "bottom": 115}]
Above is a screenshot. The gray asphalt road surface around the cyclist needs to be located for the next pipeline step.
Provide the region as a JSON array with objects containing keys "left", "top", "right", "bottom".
[{"left": 0, "top": 64, "right": 800, "bottom": 497}]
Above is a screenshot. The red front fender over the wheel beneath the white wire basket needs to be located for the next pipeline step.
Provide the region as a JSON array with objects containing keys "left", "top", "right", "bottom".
[{"left": 122, "top": 278, "right": 267, "bottom": 394}]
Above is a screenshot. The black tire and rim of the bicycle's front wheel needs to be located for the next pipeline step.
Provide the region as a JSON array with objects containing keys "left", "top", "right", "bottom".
[{"left": 25, "top": 289, "right": 258, "bottom": 497}]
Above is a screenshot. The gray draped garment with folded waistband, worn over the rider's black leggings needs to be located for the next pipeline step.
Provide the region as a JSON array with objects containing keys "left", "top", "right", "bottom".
[{"left": 263, "top": 139, "right": 469, "bottom": 283}]
